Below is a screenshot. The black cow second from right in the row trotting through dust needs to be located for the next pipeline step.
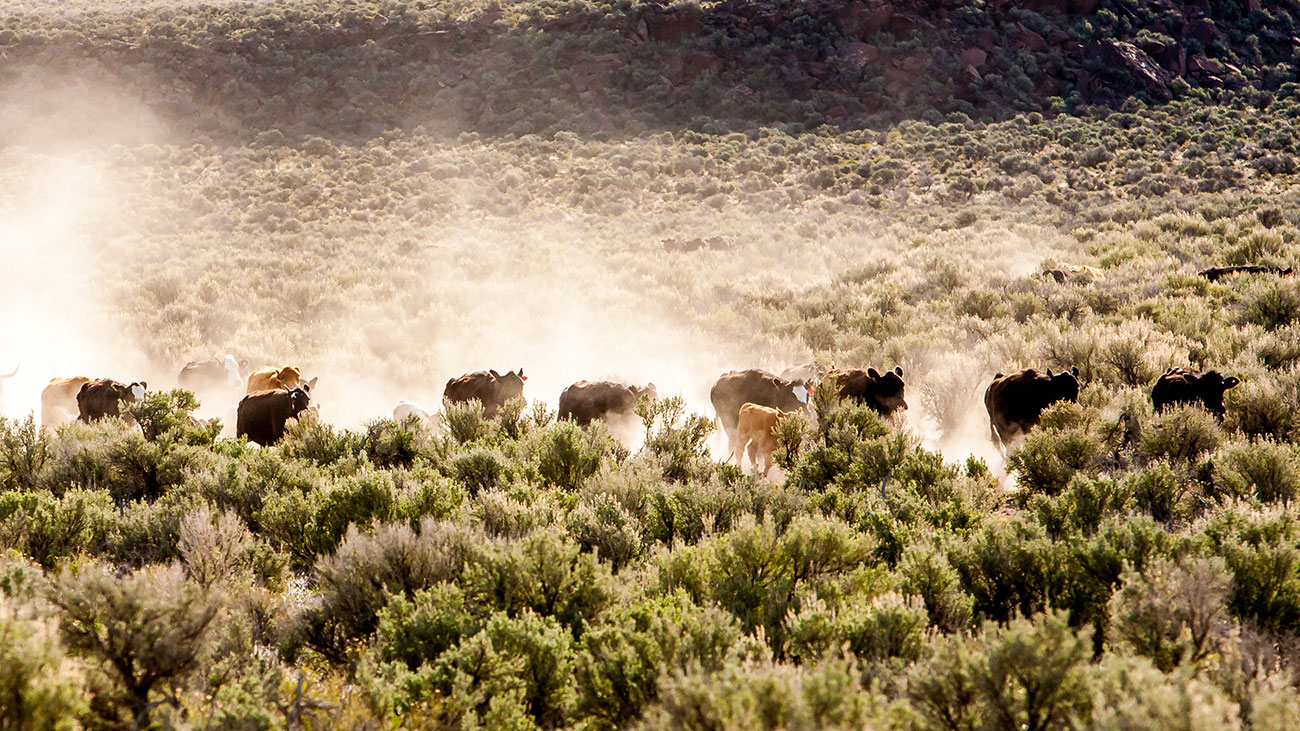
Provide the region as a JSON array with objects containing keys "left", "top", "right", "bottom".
[{"left": 984, "top": 366, "right": 1079, "bottom": 454}]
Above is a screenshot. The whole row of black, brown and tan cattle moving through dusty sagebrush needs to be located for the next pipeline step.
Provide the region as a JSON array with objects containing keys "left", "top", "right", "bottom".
[{"left": 0, "top": 355, "right": 1240, "bottom": 476}]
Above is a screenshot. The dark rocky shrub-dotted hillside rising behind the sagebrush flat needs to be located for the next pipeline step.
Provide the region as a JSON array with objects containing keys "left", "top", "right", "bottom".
[{"left": 0, "top": 0, "right": 1300, "bottom": 140}]
